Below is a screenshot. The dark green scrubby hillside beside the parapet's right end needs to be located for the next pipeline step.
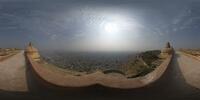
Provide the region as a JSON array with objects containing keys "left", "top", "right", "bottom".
[{"left": 126, "top": 50, "right": 162, "bottom": 78}]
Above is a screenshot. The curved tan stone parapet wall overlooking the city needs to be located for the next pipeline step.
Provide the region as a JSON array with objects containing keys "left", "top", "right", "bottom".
[{"left": 26, "top": 54, "right": 173, "bottom": 89}]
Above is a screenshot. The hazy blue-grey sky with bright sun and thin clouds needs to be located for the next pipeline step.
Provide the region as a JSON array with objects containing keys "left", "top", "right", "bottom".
[{"left": 0, "top": 0, "right": 200, "bottom": 51}]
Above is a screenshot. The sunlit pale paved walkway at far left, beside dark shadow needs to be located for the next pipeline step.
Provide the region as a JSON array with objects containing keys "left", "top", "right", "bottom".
[{"left": 0, "top": 51, "right": 28, "bottom": 91}]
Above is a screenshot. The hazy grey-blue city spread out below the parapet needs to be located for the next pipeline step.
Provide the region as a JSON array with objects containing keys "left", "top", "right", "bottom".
[{"left": 41, "top": 51, "right": 138, "bottom": 71}]
